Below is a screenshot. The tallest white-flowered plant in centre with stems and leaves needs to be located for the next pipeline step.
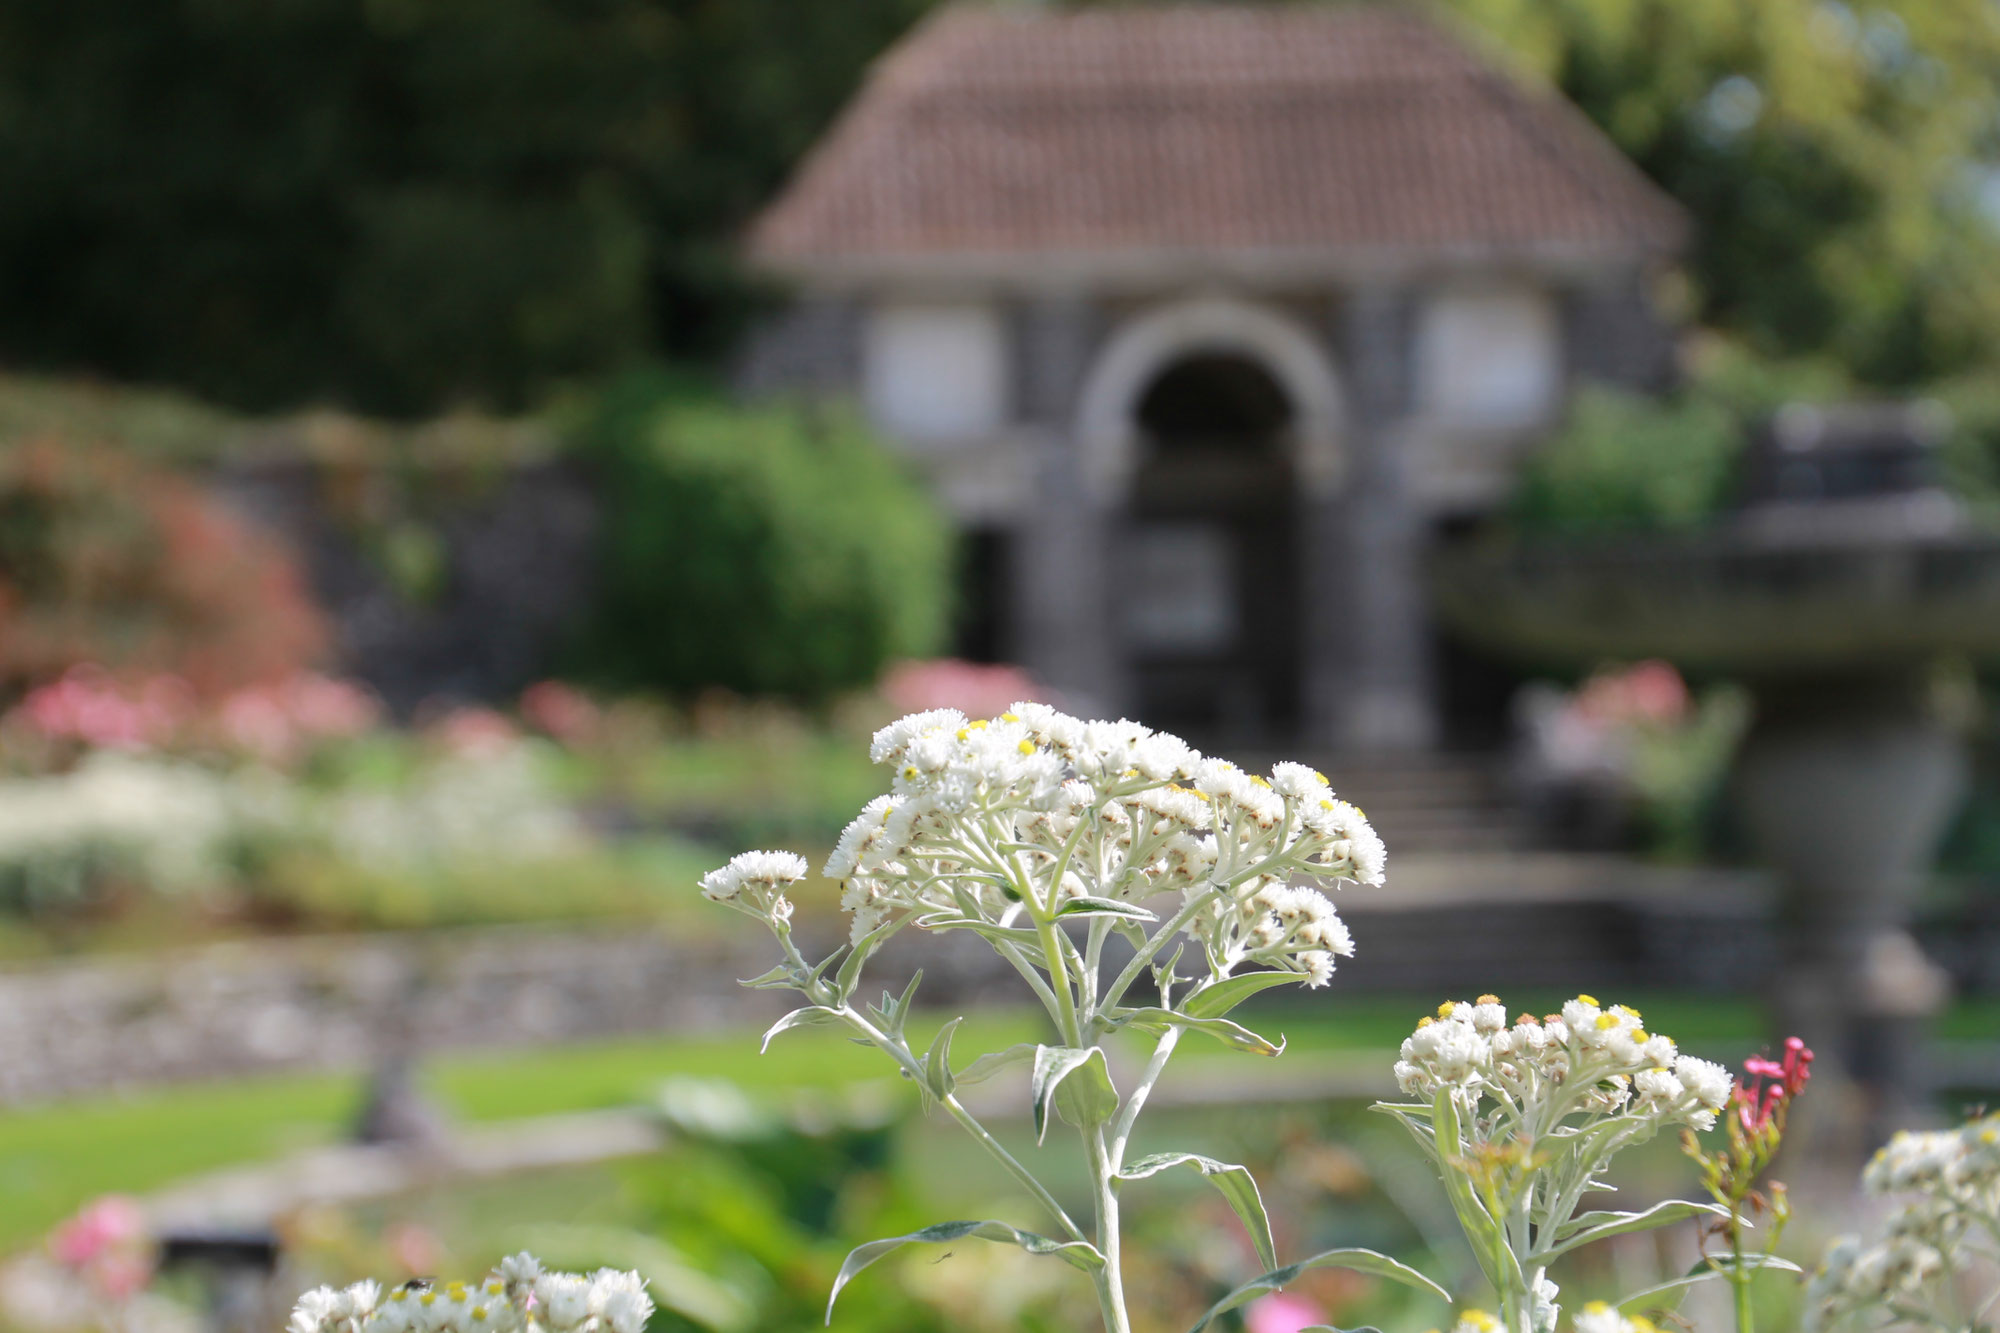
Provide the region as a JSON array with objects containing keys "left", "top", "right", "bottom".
[{"left": 702, "top": 703, "right": 1444, "bottom": 1333}]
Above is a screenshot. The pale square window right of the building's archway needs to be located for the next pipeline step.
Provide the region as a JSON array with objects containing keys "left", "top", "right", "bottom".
[{"left": 1416, "top": 288, "right": 1562, "bottom": 428}]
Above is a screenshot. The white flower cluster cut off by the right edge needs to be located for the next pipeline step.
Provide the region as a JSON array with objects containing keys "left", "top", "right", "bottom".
[{"left": 1804, "top": 1115, "right": 2000, "bottom": 1331}]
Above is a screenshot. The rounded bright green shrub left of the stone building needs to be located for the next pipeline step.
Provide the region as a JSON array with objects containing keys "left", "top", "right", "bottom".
[{"left": 578, "top": 374, "right": 950, "bottom": 703}]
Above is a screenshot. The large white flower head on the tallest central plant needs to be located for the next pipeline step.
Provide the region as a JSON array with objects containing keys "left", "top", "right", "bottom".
[{"left": 772, "top": 703, "right": 1384, "bottom": 985}]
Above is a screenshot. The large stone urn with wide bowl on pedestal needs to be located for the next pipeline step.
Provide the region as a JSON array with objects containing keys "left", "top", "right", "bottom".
[{"left": 1432, "top": 444, "right": 2000, "bottom": 1127}]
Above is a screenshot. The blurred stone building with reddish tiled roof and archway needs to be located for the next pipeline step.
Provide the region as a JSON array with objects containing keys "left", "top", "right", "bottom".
[{"left": 742, "top": 6, "right": 1684, "bottom": 751}]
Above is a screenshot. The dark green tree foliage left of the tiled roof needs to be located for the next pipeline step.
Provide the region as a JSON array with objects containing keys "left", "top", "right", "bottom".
[{"left": 0, "top": 0, "right": 926, "bottom": 414}]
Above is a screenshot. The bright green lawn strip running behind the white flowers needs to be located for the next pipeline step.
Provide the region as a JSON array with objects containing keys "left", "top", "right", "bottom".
[{"left": 0, "top": 993, "right": 2000, "bottom": 1251}]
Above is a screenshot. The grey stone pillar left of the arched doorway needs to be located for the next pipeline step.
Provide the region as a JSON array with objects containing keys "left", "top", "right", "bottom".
[{"left": 1012, "top": 296, "right": 1126, "bottom": 717}]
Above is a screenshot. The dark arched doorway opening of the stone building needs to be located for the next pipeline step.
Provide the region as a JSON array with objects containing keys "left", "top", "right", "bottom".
[{"left": 1112, "top": 350, "right": 1302, "bottom": 743}]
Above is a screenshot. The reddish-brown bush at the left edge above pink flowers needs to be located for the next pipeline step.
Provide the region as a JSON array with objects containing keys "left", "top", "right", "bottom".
[{"left": 0, "top": 436, "right": 326, "bottom": 695}]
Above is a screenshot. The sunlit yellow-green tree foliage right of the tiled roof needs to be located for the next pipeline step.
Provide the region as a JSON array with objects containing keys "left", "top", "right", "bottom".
[{"left": 1450, "top": 0, "right": 2000, "bottom": 384}]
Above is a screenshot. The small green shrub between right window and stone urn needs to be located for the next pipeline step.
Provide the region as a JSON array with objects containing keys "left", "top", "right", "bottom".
[{"left": 1514, "top": 388, "right": 1744, "bottom": 534}]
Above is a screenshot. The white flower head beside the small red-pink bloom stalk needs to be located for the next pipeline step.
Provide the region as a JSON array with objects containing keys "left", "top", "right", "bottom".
[{"left": 1396, "top": 995, "right": 1734, "bottom": 1141}]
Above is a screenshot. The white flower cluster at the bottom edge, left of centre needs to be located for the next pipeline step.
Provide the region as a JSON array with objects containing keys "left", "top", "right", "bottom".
[{"left": 286, "top": 1253, "right": 652, "bottom": 1333}]
